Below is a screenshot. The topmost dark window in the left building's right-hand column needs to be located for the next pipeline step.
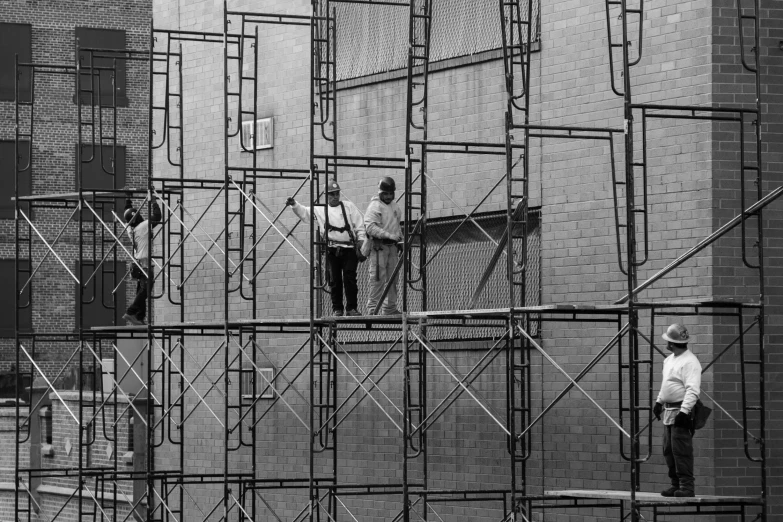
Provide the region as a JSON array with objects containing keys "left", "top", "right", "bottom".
[{"left": 74, "top": 27, "right": 128, "bottom": 107}]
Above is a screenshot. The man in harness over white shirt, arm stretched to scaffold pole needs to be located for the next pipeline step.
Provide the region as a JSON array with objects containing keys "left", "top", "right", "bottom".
[{"left": 285, "top": 181, "right": 367, "bottom": 317}]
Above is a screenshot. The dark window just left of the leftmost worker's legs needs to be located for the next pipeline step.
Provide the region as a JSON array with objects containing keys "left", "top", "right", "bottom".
[{"left": 75, "top": 261, "right": 127, "bottom": 328}]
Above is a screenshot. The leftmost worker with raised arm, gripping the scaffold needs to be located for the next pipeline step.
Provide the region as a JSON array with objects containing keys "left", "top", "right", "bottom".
[{"left": 122, "top": 197, "right": 161, "bottom": 325}]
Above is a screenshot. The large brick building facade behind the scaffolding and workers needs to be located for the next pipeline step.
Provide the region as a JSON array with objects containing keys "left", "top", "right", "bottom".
[{"left": 0, "top": 0, "right": 783, "bottom": 521}]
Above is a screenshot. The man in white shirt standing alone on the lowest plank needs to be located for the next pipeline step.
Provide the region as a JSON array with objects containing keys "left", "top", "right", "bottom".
[{"left": 653, "top": 323, "right": 701, "bottom": 497}]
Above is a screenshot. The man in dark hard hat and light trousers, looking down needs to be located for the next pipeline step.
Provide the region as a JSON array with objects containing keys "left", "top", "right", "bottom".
[{"left": 364, "top": 176, "right": 402, "bottom": 315}]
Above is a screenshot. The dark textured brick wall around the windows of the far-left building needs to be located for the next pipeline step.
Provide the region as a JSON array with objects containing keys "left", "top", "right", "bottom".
[{"left": 0, "top": 0, "right": 151, "bottom": 374}]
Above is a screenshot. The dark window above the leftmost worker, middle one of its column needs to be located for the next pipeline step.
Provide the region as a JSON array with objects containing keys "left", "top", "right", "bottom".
[{"left": 74, "top": 145, "right": 125, "bottom": 221}]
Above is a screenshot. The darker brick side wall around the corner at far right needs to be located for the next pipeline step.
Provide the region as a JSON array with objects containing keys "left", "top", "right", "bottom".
[{"left": 712, "top": 2, "right": 783, "bottom": 513}]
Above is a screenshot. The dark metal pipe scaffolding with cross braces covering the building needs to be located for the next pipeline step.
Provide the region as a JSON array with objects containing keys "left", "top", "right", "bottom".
[{"left": 15, "top": 0, "right": 783, "bottom": 522}]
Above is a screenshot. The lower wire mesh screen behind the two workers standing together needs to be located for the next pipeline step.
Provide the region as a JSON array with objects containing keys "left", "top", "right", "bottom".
[{"left": 341, "top": 210, "right": 541, "bottom": 343}]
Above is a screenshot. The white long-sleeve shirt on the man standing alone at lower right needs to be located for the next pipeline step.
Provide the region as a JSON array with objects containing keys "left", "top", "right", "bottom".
[{"left": 658, "top": 350, "right": 701, "bottom": 424}]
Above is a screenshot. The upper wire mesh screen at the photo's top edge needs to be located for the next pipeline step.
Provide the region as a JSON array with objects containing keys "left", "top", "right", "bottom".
[{"left": 334, "top": 0, "right": 540, "bottom": 80}]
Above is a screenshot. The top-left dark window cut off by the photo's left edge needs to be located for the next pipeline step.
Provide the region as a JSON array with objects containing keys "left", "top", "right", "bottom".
[{"left": 0, "top": 24, "right": 33, "bottom": 101}]
